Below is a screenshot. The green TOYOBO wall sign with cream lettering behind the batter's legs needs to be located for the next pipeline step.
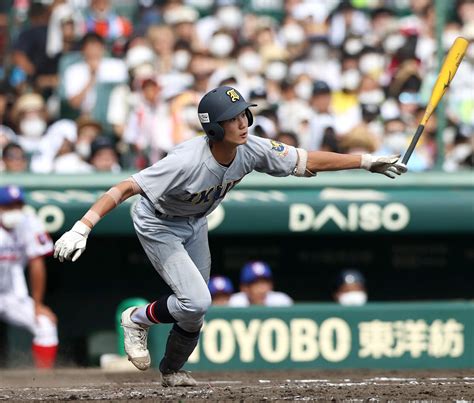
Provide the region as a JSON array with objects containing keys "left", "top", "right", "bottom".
[{"left": 149, "top": 302, "right": 474, "bottom": 369}]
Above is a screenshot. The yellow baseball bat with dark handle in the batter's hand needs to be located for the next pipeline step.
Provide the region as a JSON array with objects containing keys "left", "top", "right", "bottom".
[{"left": 402, "top": 36, "right": 469, "bottom": 165}]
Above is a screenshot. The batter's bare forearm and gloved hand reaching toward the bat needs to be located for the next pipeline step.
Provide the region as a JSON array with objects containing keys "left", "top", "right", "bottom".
[{"left": 306, "top": 151, "right": 407, "bottom": 179}]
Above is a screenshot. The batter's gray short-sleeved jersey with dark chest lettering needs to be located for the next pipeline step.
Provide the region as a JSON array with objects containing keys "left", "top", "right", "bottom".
[{"left": 133, "top": 136, "right": 297, "bottom": 217}]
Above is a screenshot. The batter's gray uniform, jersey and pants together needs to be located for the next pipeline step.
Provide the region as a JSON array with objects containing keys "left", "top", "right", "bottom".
[{"left": 132, "top": 136, "right": 297, "bottom": 332}]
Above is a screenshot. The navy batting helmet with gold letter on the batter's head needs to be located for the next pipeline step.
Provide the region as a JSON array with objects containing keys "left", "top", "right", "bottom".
[{"left": 198, "top": 86, "right": 257, "bottom": 141}]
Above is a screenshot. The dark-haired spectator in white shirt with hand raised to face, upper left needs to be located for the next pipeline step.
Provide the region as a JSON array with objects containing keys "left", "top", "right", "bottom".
[{"left": 62, "top": 33, "right": 127, "bottom": 113}]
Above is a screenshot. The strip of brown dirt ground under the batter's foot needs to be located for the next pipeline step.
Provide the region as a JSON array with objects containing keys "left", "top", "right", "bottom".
[{"left": 0, "top": 369, "right": 474, "bottom": 401}]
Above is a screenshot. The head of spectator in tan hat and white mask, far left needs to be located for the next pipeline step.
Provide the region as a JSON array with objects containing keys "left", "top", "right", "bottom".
[{"left": 12, "top": 93, "right": 48, "bottom": 155}]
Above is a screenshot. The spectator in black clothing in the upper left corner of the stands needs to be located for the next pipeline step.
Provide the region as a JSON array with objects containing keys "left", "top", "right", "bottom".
[{"left": 11, "top": 2, "right": 58, "bottom": 96}]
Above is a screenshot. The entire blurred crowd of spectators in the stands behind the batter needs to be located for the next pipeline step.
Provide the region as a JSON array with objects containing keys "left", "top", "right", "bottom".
[{"left": 0, "top": 0, "right": 474, "bottom": 173}]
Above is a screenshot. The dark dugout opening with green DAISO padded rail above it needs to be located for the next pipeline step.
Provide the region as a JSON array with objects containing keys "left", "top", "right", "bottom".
[{"left": 0, "top": 172, "right": 474, "bottom": 365}]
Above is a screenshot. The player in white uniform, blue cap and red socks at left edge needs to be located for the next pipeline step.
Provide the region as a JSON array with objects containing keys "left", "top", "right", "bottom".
[{"left": 0, "top": 186, "right": 58, "bottom": 368}]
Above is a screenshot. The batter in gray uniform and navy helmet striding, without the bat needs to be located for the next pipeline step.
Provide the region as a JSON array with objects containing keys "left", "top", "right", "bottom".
[{"left": 54, "top": 86, "right": 406, "bottom": 386}]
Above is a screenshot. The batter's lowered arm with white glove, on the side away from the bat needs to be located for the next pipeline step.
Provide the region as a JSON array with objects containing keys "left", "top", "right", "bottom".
[{"left": 54, "top": 178, "right": 141, "bottom": 262}]
